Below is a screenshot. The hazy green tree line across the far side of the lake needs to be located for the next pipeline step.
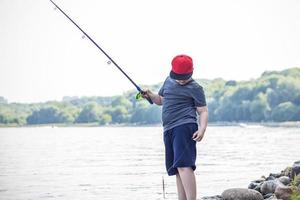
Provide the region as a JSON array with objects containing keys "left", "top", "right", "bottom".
[{"left": 0, "top": 68, "right": 300, "bottom": 125}]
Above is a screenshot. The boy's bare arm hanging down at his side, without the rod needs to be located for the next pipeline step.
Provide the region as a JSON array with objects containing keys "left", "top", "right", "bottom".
[{"left": 193, "top": 106, "right": 208, "bottom": 142}]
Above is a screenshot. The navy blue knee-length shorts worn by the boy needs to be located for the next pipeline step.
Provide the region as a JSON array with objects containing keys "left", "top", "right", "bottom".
[{"left": 164, "top": 123, "right": 198, "bottom": 176}]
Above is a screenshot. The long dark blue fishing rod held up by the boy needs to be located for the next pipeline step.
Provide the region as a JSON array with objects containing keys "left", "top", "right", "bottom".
[{"left": 50, "top": 0, "right": 153, "bottom": 104}]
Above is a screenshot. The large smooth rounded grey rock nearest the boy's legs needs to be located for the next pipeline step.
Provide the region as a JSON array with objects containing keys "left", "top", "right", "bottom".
[{"left": 221, "top": 188, "right": 264, "bottom": 200}]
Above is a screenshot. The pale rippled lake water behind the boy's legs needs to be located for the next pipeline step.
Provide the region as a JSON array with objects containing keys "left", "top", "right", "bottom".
[{"left": 0, "top": 126, "right": 300, "bottom": 200}]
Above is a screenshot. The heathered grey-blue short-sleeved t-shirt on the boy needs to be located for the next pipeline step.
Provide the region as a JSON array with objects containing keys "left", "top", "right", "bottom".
[{"left": 158, "top": 77, "right": 206, "bottom": 131}]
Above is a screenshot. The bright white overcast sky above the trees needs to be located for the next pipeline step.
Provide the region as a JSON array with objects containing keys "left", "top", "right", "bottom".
[{"left": 0, "top": 0, "right": 300, "bottom": 102}]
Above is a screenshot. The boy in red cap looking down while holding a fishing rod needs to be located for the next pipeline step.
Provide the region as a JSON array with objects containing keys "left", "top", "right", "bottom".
[{"left": 143, "top": 55, "right": 208, "bottom": 200}]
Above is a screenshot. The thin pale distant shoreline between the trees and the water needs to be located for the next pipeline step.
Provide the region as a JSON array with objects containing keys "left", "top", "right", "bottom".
[{"left": 0, "top": 121, "right": 300, "bottom": 128}]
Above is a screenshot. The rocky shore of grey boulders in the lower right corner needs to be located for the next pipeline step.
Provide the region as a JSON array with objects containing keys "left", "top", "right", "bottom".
[{"left": 201, "top": 161, "right": 300, "bottom": 200}]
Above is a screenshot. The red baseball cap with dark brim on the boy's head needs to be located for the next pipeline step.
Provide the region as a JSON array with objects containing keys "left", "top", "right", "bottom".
[{"left": 170, "top": 54, "right": 194, "bottom": 80}]
